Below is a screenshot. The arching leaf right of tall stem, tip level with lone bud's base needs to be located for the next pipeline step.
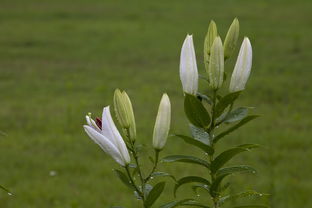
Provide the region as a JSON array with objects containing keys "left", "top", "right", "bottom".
[{"left": 211, "top": 144, "right": 259, "bottom": 173}]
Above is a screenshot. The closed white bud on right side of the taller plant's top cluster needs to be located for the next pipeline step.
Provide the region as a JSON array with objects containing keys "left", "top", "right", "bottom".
[{"left": 229, "top": 37, "right": 252, "bottom": 92}]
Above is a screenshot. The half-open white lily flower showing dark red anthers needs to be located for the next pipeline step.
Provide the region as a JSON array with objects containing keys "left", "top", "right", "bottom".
[{"left": 83, "top": 106, "right": 130, "bottom": 166}]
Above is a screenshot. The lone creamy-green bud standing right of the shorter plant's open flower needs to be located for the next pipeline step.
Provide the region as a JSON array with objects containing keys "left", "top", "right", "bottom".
[{"left": 153, "top": 93, "right": 171, "bottom": 150}]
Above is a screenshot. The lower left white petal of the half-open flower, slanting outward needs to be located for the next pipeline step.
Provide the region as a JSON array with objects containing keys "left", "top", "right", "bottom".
[{"left": 83, "top": 125, "right": 125, "bottom": 166}]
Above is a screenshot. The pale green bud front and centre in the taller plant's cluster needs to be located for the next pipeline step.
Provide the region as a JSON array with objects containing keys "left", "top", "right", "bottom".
[{"left": 207, "top": 36, "right": 224, "bottom": 90}]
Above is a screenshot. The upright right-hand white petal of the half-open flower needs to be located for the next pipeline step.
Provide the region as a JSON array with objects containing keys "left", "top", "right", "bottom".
[{"left": 102, "top": 106, "right": 130, "bottom": 163}]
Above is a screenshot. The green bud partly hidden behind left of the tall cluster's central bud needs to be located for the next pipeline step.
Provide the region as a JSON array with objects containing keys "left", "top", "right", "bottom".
[{"left": 204, "top": 20, "right": 218, "bottom": 69}]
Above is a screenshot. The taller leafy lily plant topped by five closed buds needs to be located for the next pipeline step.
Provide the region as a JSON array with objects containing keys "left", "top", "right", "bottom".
[{"left": 161, "top": 18, "right": 267, "bottom": 208}]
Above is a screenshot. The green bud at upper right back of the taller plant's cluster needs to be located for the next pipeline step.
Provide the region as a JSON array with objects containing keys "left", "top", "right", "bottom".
[{"left": 224, "top": 18, "right": 239, "bottom": 59}]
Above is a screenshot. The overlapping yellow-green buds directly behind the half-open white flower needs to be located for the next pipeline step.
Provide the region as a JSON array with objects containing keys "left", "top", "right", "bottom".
[{"left": 114, "top": 89, "right": 136, "bottom": 139}]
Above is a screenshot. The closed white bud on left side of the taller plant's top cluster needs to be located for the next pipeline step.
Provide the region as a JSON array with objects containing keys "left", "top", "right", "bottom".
[{"left": 180, "top": 35, "right": 198, "bottom": 95}]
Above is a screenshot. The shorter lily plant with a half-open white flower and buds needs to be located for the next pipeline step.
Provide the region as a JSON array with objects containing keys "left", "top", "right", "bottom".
[{"left": 83, "top": 89, "right": 171, "bottom": 208}]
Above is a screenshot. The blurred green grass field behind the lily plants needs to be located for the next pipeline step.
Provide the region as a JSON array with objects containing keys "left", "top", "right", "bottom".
[{"left": 0, "top": 0, "right": 312, "bottom": 208}]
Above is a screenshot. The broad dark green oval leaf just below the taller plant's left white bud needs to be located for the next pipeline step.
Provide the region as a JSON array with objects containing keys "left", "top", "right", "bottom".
[{"left": 184, "top": 93, "right": 211, "bottom": 128}]
